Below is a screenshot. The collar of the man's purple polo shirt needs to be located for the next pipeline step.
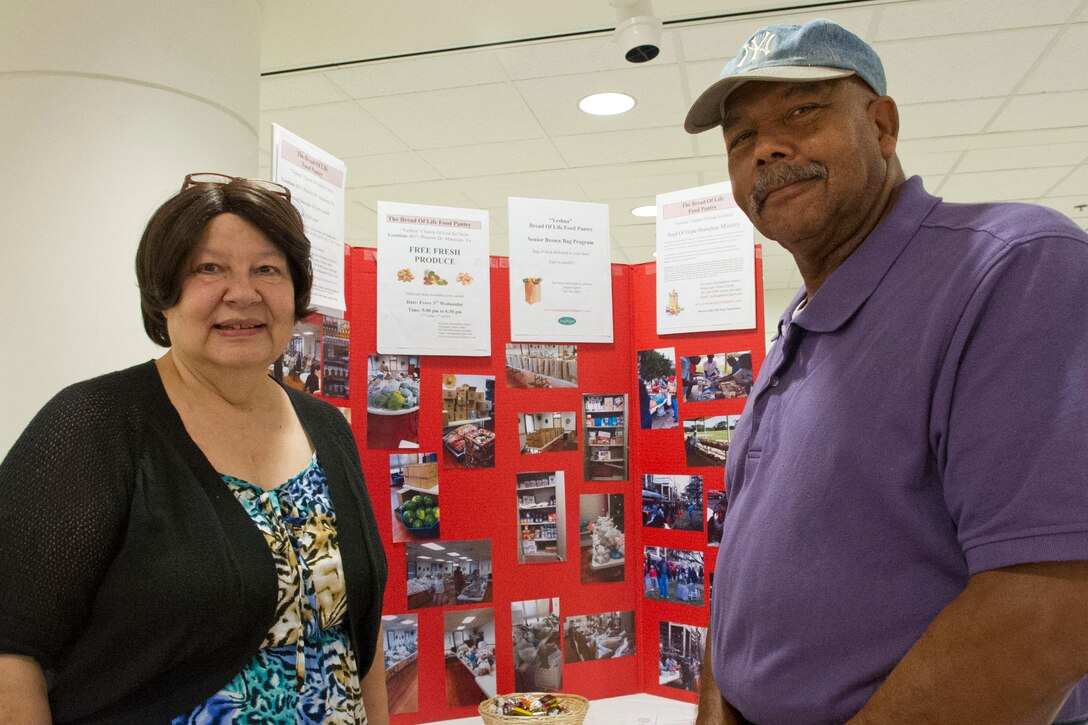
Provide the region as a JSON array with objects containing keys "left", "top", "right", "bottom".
[{"left": 778, "top": 176, "right": 940, "bottom": 336}]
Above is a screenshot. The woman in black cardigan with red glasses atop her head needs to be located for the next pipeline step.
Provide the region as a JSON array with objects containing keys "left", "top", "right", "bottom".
[{"left": 0, "top": 174, "right": 388, "bottom": 723}]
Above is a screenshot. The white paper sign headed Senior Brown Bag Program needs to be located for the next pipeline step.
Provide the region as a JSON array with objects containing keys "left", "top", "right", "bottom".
[{"left": 508, "top": 197, "right": 613, "bottom": 343}]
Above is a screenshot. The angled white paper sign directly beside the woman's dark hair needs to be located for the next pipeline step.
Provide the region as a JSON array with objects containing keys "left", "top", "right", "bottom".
[{"left": 272, "top": 123, "right": 347, "bottom": 317}]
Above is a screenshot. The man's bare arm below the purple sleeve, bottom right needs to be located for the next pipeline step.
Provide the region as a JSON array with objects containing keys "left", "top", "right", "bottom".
[{"left": 850, "top": 562, "right": 1088, "bottom": 725}]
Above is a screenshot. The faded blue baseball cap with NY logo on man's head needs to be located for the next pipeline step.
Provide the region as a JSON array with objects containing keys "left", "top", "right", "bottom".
[{"left": 683, "top": 20, "right": 888, "bottom": 134}]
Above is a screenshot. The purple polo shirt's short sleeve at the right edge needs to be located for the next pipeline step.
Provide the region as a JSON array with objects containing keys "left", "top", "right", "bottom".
[{"left": 935, "top": 231, "right": 1088, "bottom": 574}]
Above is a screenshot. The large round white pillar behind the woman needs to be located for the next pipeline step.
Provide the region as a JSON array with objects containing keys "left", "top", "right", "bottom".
[{"left": 0, "top": 0, "right": 260, "bottom": 457}]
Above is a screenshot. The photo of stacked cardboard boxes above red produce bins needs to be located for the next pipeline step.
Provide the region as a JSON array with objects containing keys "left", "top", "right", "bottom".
[{"left": 442, "top": 373, "right": 495, "bottom": 468}]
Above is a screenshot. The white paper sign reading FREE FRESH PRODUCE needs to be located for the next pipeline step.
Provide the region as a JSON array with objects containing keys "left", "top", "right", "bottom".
[{"left": 378, "top": 201, "right": 491, "bottom": 356}]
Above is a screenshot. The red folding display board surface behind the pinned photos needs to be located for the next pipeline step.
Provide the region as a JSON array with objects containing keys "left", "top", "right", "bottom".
[{"left": 330, "top": 248, "right": 764, "bottom": 725}]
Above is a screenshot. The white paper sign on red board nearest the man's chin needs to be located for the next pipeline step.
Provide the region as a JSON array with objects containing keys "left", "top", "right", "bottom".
[{"left": 657, "top": 183, "right": 755, "bottom": 335}]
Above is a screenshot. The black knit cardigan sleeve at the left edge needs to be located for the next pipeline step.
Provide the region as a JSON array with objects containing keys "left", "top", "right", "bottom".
[{"left": 0, "top": 383, "right": 133, "bottom": 668}]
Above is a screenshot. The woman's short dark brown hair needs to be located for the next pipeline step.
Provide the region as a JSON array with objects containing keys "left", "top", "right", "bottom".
[{"left": 136, "top": 181, "right": 313, "bottom": 347}]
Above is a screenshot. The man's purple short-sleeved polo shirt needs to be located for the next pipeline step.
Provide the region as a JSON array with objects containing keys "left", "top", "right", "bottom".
[{"left": 710, "top": 177, "right": 1088, "bottom": 725}]
